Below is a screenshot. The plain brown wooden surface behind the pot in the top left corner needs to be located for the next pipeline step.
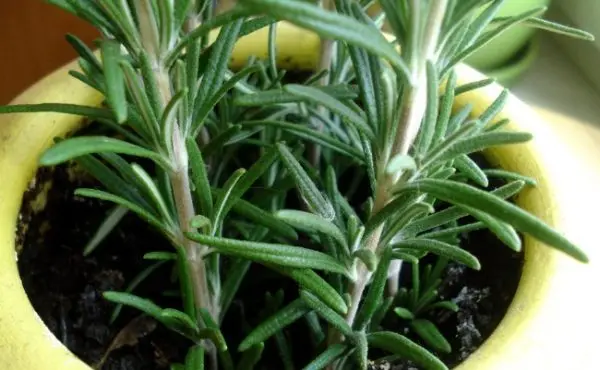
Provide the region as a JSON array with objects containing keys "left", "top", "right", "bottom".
[{"left": 0, "top": 0, "right": 96, "bottom": 104}]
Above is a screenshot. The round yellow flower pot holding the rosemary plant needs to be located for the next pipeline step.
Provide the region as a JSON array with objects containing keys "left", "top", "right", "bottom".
[{"left": 0, "top": 23, "right": 600, "bottom": 370}]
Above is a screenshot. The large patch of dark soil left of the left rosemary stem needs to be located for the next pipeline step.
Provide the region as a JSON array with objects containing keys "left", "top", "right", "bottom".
[{"left": 18, "top": 168, "right": 188, "bottom": 370}]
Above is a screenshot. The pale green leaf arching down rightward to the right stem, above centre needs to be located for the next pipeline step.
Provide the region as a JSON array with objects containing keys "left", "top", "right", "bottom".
[{"left": 284, "top": 84, "right": 375, "bottom": 139}]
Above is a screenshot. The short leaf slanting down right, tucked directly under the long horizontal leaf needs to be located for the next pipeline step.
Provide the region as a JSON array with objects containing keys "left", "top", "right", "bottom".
[{"left": 277, "top": 269, "right": 348, "bottom": 315}]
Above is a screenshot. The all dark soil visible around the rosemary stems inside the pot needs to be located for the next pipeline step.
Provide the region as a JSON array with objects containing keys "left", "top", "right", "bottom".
[{"left": 17, "top": 160, "right": 522, "bottom": 370}]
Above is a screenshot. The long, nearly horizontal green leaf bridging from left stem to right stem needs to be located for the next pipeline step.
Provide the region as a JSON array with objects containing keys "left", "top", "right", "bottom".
[{"left": 187, "top": 233, "right": 346, "bottom": 274}]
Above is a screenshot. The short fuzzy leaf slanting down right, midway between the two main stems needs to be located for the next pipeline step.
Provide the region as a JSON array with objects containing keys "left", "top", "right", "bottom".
[{"left": 277, "top": 144, "right": 335, "bottom": 220}]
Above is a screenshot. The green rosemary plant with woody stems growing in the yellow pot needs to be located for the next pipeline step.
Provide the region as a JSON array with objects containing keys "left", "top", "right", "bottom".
[{"left": 0, "top": 0, "right": 592, "bottom": 370}]
